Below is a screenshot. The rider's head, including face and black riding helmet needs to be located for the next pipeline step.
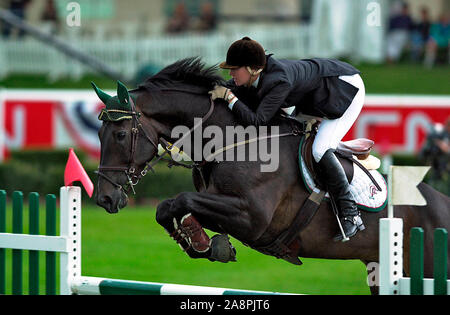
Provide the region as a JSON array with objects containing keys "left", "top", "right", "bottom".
[{"left": 220, "top": 37, "right": 266, "bottom": 86}]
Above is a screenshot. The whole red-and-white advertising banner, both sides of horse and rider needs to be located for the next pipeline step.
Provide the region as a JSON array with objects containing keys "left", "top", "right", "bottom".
[{"left": 0, "top": 90, "right": 450, "bottom": 161}]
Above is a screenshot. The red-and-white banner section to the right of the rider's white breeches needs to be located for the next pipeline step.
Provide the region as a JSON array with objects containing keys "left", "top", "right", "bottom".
[{"left": 344, "top": 95, "right": 450, "bottom": 153}]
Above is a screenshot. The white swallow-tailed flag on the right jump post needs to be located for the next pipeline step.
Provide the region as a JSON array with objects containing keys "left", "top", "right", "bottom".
[{"left": 391, "top": 166, "right": 430, "bottom": 206}]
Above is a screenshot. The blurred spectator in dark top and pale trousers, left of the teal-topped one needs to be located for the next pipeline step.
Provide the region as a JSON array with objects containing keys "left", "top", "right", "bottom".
[{"left": 387, "top": 3, "right": 414, "bottom": 63}]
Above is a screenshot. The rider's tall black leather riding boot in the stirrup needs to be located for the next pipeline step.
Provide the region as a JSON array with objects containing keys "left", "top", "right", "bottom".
[{"left": 319, "top": 149, "right": 364, "bottom": 241}]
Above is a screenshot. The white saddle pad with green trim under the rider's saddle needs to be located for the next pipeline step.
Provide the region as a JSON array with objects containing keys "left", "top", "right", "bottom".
[{"left": 299, "top": 154, "right": 387, "bottom": 212}]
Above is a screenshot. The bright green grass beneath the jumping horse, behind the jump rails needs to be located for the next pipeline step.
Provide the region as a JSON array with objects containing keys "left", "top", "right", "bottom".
[{"left": 0, "top": 202, "right": 369, "bottom": 295}]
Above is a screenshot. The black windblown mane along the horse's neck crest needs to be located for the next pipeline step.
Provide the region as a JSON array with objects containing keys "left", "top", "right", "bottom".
[{"left": 139, "top": 57, "right": 224, "bottom": 90}]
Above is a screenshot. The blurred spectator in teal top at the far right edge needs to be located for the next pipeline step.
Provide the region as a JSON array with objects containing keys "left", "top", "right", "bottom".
[{"left": 424, "top": 13, "right": 450, "bottom": 68}]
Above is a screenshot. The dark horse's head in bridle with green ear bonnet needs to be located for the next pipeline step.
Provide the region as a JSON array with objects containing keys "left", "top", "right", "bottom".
[{"left": 92, "top": 82, "right": 158, "bottom": 213}]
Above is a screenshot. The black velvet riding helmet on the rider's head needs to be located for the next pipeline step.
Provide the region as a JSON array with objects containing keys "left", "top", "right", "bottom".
[{"left": 219, "top": 36, "right": 266, "bottom": 69}]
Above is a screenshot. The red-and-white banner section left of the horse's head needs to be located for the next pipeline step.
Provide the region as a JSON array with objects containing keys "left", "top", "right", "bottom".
[{"left": 0, "top": 90, "right": 103, "bottom": 160}]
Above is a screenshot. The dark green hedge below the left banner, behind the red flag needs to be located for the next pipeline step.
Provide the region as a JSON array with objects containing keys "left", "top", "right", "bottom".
[{"left": 0, "top": 150, "right": 195, "bottom": 203}]
